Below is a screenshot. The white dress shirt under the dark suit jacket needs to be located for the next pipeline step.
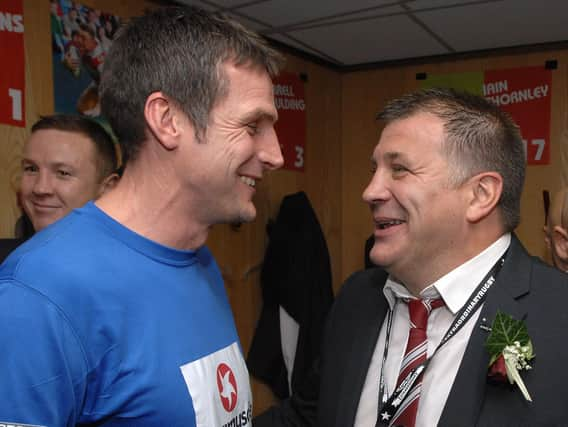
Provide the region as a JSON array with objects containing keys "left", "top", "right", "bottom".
[{"left": 354, "top": 233, "right": 511, "bottom": 427}]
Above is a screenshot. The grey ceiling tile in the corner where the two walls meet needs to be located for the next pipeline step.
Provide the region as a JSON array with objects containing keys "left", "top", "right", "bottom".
[{"left": 290, "top": 15, "right": 447, "bottom": 64}]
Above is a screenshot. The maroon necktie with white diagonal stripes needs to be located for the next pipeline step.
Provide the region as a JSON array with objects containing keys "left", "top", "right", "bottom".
[{"left": 391, "top": 299, "right": 444, "bottom": 427}]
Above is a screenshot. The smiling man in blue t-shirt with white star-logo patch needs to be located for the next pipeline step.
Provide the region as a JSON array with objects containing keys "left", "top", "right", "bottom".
[{"left": 0, "top": 7, "right": 283, "bottom": 427}]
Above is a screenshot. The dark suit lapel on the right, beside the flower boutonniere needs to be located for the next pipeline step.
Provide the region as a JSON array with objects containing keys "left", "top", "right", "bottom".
[{"left": 439, "top": 235, "right": 532, "bottom": 426}]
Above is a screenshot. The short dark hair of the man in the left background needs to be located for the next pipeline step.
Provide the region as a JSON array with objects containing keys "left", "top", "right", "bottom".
[{"left": 32, "top": 114, "right": 118, "bottom": 181}]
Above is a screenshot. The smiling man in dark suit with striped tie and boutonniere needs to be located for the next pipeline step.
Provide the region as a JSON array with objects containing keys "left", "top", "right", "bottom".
[{"left": 254, "top": 89, "right": 568, "bottom": 427}]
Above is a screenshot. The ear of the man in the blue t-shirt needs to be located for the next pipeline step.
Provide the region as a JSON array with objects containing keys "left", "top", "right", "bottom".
[{"left": 144, "top": 92, "right": 182, "bottom": 150}]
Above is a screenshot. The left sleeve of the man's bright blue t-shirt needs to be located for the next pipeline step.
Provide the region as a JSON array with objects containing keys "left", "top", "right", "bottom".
[{"left": 0, "top": 280, "right": 87, "bottom": 427}]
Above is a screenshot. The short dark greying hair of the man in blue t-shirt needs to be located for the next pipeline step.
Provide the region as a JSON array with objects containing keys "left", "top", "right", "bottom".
[{"left": 100, "top": 6, "right": 283, "bottom": 165}]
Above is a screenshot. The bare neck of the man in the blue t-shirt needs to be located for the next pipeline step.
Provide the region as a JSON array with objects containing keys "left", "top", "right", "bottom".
[{"left": 96, "top": 153, "right": 209, "bottom": 250}]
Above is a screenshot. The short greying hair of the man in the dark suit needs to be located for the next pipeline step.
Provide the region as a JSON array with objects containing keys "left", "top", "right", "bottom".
[{"left": 377, "top": 88, "right": 526, "bottom": 231}]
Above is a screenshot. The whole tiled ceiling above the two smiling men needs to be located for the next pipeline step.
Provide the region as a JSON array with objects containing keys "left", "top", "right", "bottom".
[{"left": 177, "top": 0, "right": 568, "bottom": 69}]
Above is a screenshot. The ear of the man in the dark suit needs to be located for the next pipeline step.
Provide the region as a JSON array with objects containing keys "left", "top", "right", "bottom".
[{"left": 466, "top": 172, "right": 503, "bottom": 222}]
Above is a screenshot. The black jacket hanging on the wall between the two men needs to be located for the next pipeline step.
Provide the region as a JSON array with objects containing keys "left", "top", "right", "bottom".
[{"left": 247, "top": 192, "right": 333, "bottom": 398}]
